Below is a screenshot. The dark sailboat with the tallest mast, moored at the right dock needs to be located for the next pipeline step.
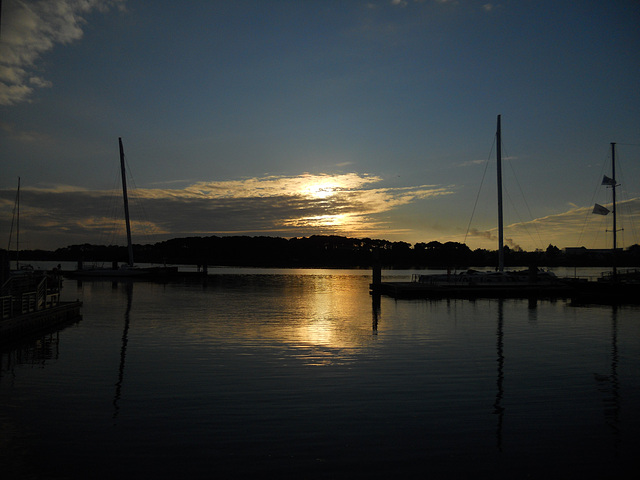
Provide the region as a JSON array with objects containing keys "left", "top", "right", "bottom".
[{"left": 371, "top": 115, "right": 570, "bottom": 296}]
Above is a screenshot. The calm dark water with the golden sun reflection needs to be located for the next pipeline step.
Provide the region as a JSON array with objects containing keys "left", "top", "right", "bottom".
[{"left": 0, "top": 269, "right": 640, "bottom": 479}]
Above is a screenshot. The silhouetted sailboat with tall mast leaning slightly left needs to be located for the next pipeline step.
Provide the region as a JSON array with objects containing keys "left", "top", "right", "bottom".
[{"left": 70, "top": 138, "right": 178, "bottom": 277}]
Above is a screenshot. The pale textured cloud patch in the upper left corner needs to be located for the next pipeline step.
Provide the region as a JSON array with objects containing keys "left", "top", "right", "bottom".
[{"left": 0, "top": 0, "right": 125, "bottom": 105}]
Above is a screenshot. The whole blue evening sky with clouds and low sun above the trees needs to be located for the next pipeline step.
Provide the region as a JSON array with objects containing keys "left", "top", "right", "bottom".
[{"left": 0, "top": 0, "right": 640, "bottom": 251}]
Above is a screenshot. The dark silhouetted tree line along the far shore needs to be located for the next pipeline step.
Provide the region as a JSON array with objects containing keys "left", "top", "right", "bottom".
[{"left": 5, "top": 235, "right": 640, "bottom": 269}]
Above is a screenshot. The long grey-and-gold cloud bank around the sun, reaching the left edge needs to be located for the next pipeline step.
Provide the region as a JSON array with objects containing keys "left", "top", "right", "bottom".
[{"left": 0, "top": 173, "right": 452, "bottom": 249}]
